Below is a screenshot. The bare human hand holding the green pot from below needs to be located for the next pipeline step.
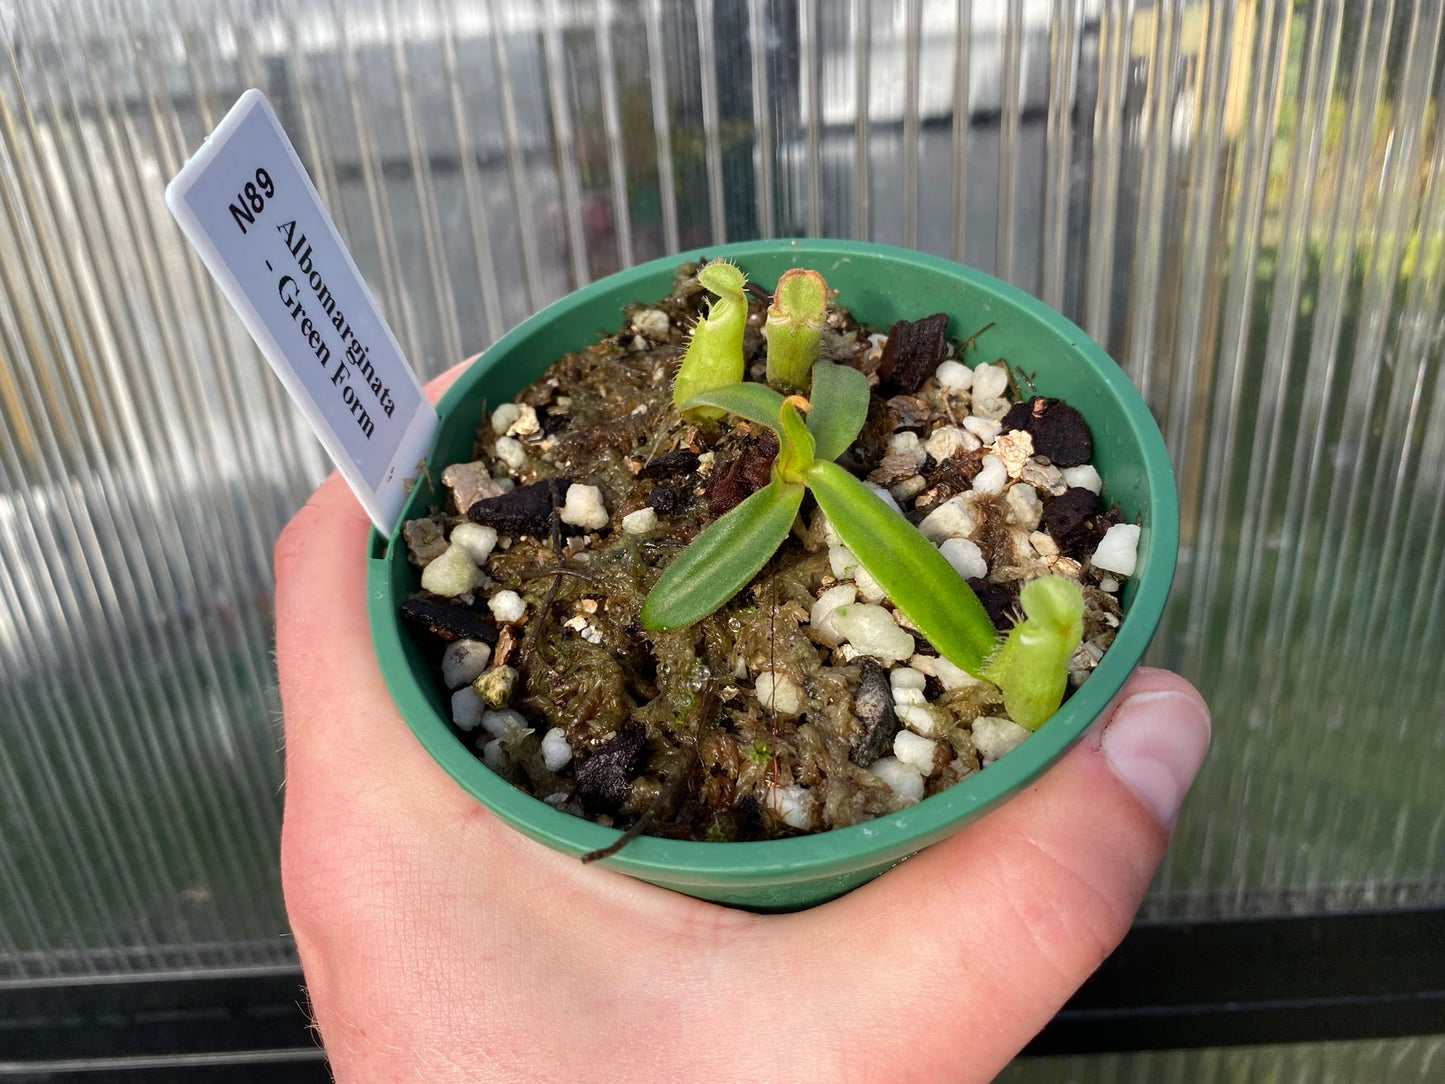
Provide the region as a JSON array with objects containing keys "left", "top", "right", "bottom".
[{"left": 276, "top": 367, "right": 1209, "bottom": 1083}]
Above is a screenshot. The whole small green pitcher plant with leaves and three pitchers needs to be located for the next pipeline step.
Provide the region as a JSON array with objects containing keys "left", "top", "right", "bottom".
[{"left": 642, "top": 263, "right": 1084, "bottom": 730}]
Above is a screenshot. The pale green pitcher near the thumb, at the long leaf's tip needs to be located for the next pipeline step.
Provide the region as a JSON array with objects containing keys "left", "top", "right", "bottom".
[{"left": 983, "top": 575, "right": 1084, "bottom": 730}]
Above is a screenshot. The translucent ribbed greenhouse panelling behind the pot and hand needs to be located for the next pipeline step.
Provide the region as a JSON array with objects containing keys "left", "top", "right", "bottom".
[{"left": 0, "top": 0, "right": 1445, "bottom": 1081}]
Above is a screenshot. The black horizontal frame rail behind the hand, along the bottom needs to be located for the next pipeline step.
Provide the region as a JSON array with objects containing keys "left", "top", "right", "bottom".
[{"left": 0, "top": 906, "right": 1445, "bottom": 1084}]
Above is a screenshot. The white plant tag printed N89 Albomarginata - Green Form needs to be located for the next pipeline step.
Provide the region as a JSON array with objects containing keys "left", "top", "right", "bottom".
[{"left": 166, "top": 90, "right": 436, "bottom": 535}]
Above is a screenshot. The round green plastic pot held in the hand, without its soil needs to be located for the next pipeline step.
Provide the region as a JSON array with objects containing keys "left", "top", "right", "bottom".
[{"left": 368, "top": 240, "right": 1179, "bottom": 911}]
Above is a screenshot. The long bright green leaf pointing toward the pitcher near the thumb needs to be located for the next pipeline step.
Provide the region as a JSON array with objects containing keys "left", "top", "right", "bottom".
[{"left": 808, "top": 460, "right": 998, "bottom": 676}]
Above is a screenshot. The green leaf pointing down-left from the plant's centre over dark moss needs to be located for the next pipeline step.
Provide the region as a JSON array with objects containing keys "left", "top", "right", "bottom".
[{"left": 642, "top": 477, "right": 803, "bottom": 632}]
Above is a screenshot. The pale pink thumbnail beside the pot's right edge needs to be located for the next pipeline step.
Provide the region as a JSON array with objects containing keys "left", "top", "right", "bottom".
[{"left": 1100, "top": 691, "right": 1209, "bottom": 830}]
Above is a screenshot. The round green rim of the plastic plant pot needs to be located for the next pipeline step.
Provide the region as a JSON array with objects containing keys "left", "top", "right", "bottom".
[{"left": 368, "top": 238, "right": 1179, "bottom": 890}]
